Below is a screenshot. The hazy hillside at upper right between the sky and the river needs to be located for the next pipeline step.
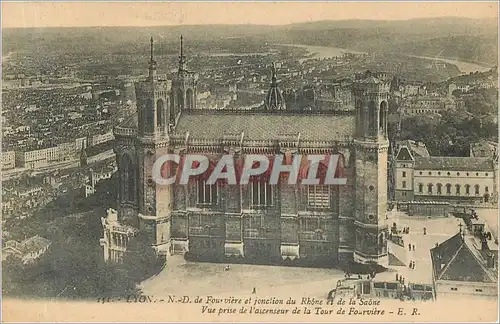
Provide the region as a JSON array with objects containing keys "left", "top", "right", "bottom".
[{"left": 278, "top": 18, "right": 498, "bottom": 65}]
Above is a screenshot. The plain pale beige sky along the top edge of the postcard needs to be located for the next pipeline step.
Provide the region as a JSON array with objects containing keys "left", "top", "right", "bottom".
[{"left": 2, "top": 1, "right": 498, "bottom": 28}]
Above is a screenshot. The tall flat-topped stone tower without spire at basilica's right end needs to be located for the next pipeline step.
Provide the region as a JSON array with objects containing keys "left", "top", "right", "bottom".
[{"left": 354, "top": 71, "right": 390, "bottom": 266}]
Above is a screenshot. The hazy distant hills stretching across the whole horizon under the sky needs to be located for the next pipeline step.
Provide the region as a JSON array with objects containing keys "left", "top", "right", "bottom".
[{"left": 2, "top": 17, "right": 498, "bottom": 64}]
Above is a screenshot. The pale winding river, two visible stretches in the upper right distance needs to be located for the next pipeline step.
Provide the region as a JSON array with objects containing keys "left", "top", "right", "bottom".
[{"left": 276, "top": 44, "right": 492, "bottom": 74}]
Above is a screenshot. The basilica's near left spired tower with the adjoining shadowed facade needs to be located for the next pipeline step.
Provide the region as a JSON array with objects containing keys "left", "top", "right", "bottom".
[{"left": 116, "top": 38, "right": 172, "bottom": 250}]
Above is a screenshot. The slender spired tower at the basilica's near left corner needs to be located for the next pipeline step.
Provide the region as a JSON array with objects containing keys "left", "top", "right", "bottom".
[{"left": 135, "top": 38, "right": 173, "bottom": 251}]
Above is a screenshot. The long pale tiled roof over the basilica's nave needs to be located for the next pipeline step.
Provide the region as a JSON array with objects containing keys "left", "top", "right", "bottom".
[{"left": 175, "top": 111, "right": 355, "bottom": 141}]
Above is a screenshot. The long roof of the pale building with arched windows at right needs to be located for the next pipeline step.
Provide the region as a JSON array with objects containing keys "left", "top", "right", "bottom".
[{"left": 415, "top": 156, "right": 493, "bottom": 171}]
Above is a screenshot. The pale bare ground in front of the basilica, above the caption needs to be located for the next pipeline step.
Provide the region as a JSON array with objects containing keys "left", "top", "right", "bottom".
[{"left": 142, "top": 255, "right": 344, "bottom": 298}]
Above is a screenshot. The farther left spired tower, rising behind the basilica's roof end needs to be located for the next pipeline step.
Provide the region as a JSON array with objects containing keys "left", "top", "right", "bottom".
[{"left": 170, "top": 35, "right": 198, "bottom": 114}]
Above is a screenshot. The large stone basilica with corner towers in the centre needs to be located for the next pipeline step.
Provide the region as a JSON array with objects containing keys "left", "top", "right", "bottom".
[{"left": 101, "top": 37, "right": 390, "bottom": 266}]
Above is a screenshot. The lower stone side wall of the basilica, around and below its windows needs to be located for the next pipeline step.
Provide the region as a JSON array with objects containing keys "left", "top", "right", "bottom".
[{"left": 172, "top": 159, "right": 356, "bottom": 263}]
